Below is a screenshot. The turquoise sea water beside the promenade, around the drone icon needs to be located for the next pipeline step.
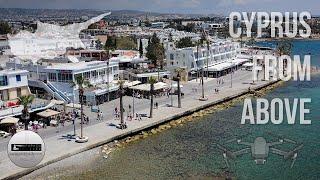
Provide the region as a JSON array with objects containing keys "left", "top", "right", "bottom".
[{"left": 46, "top": 41, "right": 320, "bottom": 180}]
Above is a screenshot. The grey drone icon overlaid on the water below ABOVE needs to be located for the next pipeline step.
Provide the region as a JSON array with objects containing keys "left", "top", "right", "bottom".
[{"left": 216, "top": 133, "right": 303, "bottom": 168}]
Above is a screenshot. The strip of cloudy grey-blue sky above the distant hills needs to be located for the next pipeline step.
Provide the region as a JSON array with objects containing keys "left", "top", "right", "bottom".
[{"left": 0, "top": 0, "right": 320, "bottom": 15}]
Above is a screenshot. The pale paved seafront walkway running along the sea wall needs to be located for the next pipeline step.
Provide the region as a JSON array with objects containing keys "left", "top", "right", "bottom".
[{"left": 0, "top": 71, "right": 276, "bottom": 179}]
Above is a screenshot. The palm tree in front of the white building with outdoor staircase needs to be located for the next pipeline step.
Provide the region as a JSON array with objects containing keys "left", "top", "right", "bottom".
[{"left": 74, "top": 75, "right": 92, "bottom": 139}]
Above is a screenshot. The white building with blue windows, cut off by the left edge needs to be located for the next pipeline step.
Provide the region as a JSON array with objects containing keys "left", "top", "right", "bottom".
[{"left": 0, "top": 69, "right": 30, "bottom": 101}]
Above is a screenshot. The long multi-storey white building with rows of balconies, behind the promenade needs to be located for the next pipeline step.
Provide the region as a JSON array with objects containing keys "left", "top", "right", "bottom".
[{"left": 166, "top": 41, "right": 245, "bottom": 79}]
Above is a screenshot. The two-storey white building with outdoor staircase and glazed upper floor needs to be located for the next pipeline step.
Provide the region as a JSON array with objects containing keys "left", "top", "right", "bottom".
[{"left": 7, "top": 60, "right": 119, "bottom": 104}]
